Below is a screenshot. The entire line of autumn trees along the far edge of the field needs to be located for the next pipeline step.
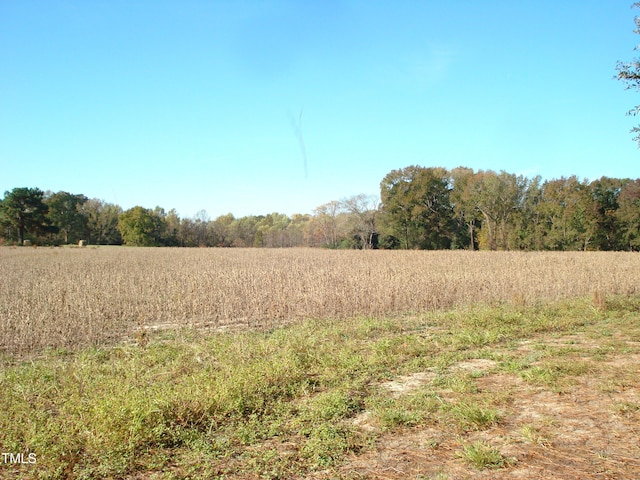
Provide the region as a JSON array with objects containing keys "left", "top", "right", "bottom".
[{"left": 0, "top": 166, "right": 640, "bottom": 251}]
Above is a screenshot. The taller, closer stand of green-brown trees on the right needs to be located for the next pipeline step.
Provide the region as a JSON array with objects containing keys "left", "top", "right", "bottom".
[{"left": 380, "top": 166, "right": 640, "bottom": 251}]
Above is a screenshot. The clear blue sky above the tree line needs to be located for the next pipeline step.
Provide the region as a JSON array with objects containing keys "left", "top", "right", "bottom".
[{"left": 0, "top": 0, "right": 640, "bottom": 218}]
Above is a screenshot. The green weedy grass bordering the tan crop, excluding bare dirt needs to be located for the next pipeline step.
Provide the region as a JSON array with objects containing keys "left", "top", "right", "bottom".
[{"left": 0, "top": 299, "right": 639, "bottom": 480}]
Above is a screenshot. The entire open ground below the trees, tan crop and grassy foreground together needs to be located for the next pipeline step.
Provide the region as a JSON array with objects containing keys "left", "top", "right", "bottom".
[{"left": 0, "top": 247, "right": 640, "bottom": 480}]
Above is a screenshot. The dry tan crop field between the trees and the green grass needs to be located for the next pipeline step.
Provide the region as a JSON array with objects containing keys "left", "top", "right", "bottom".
[{"left": 0, "top": 247, "right": 640, "bottom": 353}]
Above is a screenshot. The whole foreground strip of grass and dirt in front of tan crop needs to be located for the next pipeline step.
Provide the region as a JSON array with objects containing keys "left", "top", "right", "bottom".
[{"left": 0, "top": 296, "right": 640, "bottom": 479}]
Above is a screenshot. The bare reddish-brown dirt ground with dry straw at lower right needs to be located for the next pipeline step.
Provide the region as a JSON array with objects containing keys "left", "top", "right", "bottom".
[{"left": 338, "top": 336, "right": 640, "bottom": 479}]
